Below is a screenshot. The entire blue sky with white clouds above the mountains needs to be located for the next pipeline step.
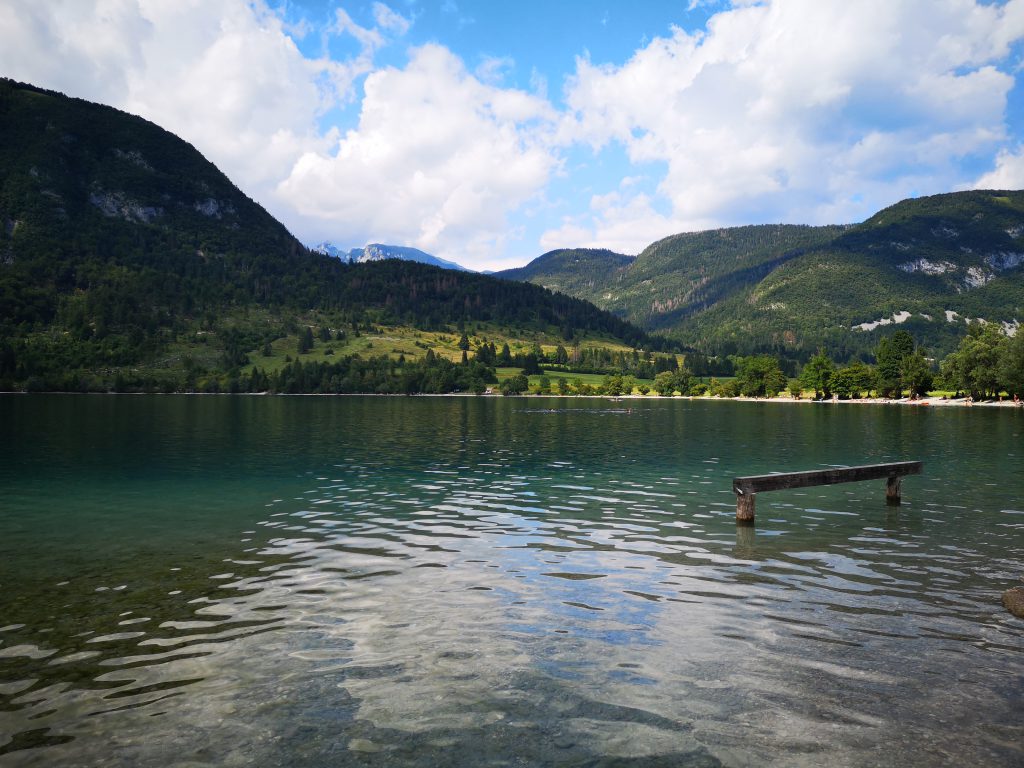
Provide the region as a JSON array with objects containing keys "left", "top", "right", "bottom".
[{"left": 0, "top": 0, "right": 1024, "bottom": 269}]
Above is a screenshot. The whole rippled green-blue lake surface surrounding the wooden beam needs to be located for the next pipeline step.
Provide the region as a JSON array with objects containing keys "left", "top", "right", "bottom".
[{"left": 0, "top": 395, "right": 1024, "bottom": 766}]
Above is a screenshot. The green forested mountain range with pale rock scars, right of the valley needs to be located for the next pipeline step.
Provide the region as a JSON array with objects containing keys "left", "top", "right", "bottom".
[{"left": 497, "top": 191, "right": 1024, "bottom": 358}]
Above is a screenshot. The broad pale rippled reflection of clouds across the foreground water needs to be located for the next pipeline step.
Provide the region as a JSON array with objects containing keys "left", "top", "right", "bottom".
[{"left": 8, "top": 438, "right": 1020, "bottom": 765}]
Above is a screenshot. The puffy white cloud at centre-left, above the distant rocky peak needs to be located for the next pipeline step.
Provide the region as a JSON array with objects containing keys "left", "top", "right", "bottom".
[{"left": 279, "top": 45, "right": 557, "bottom": 266}]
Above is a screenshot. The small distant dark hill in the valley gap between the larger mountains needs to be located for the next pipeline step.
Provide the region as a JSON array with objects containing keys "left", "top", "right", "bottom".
[{"left": 494, "top": 248, "right": 636, "bottom": 296}]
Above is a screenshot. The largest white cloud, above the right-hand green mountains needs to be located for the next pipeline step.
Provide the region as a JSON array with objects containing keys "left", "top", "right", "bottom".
[{"left": 552, "top": 0, "right": 1024, "bottom": 249}]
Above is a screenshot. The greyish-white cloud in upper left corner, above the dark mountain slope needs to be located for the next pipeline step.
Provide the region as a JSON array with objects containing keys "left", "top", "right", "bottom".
[{"left": 0, "top": 0, "right": 409, "bottom": 234}]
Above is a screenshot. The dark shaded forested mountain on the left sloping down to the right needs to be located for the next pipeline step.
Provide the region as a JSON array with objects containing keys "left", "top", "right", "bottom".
[{"left": 0, "top": 80, "right": 664, "bottom": 388}]
